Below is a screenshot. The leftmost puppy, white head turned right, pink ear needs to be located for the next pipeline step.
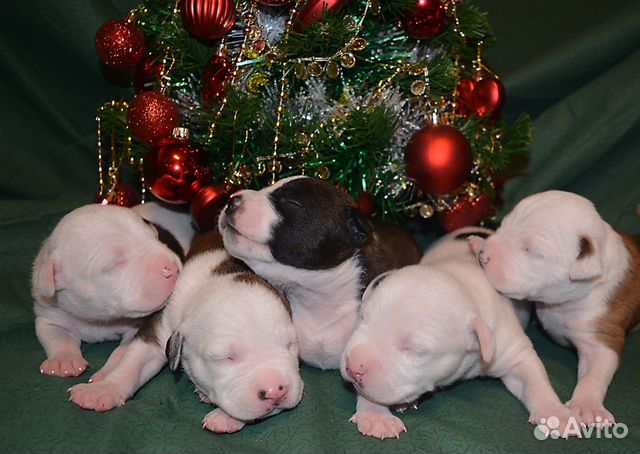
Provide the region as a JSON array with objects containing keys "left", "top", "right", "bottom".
[{"left": 31, "top": 205, "right": 189, "bottom": 377}]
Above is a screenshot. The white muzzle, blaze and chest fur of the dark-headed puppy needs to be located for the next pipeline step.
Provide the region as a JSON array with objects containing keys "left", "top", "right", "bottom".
[{"left": 219, "top": 176, "right": 360, "bottom": 369}]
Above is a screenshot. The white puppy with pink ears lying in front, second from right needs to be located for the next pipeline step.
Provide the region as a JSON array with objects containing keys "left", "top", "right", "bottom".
[{"left": 340, "top": 227, "right": 570, "bottom": 439}]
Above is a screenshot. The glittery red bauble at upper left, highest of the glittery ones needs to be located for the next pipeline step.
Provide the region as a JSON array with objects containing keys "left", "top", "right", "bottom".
[{"left": 96, "top": 19, "right": 145, "bottom": 69}]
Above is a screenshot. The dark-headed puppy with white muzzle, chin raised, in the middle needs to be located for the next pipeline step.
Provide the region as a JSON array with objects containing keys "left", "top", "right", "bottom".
[{"left": 219, "top": 176, "right": 421, "bottom": 369}]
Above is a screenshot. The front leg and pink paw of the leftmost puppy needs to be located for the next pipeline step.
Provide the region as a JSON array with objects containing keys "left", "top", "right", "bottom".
[{"left": 35, "top": 317, "right": 88, "bottom": 377}]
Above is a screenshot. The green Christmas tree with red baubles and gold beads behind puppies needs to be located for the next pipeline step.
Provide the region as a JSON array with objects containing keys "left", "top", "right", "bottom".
[{"left": 96, "top": 0, "right": 531, "bottom": 230}]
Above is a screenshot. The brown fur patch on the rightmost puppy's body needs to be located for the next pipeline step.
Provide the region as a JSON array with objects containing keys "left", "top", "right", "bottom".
[{"left": 596, "top": 232, "right": 640, "bottom": 356}]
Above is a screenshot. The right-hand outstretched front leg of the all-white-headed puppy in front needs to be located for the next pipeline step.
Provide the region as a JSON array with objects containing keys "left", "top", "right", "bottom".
[{"left": 500, "top": 347, "right": 578, "bottom": 437}]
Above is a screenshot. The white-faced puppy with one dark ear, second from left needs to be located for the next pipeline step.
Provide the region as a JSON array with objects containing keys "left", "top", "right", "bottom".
[{"left": 70, "top": 231, "right": 303, "bottom": 433}]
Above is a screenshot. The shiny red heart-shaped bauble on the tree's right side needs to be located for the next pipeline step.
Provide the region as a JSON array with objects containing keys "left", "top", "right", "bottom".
[{"left": 456, "top": 78, "right": 506, "bottom": 120}]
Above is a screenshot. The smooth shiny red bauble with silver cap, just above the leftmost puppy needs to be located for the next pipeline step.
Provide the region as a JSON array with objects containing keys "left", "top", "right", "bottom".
[{"left": 144, "top": 137, "right": 211, "bottom": 204}]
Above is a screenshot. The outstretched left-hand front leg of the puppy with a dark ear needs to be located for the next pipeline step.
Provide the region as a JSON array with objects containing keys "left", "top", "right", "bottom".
[{"left": 69, "top": 339, "right": 167, "bottom": 411}]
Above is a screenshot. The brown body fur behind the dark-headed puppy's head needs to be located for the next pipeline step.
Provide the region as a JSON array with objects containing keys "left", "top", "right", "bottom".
[{"left": 361, "top": 221, "right": 422, "bottom": 291}]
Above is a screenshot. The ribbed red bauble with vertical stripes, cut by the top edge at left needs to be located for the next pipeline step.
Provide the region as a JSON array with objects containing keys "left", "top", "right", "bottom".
[{"left": 180, "top": 0, "right": 236, "bottom": 40}]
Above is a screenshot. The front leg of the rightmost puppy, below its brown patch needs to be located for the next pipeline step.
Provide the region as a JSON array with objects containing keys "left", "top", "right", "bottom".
[{"left": 567, "top": 341, "right": 619, "bottom": 426}]
